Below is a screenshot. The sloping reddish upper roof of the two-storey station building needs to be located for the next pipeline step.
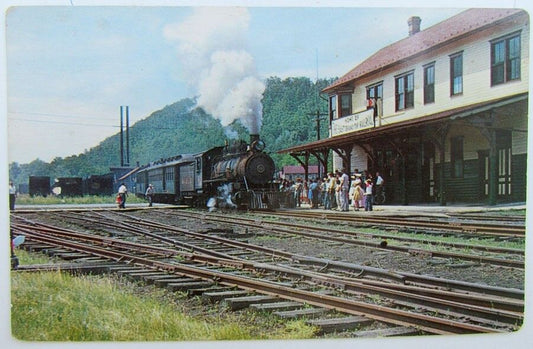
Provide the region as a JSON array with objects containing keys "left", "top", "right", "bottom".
[{"left": 322, "top": 8, "right": 527, "bottom": 93}]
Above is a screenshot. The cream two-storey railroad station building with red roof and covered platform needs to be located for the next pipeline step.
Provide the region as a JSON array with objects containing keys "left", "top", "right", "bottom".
[{"left": 280, "top": 9, "right": 529, "bottom": 205}]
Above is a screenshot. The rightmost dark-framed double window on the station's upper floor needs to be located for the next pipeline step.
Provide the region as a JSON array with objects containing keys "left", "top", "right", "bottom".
[{"left": 490, "top": 34, "right": 521, "bottom": 86}]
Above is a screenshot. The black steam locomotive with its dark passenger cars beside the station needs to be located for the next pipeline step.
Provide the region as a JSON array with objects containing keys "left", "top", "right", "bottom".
[{"left": 135, "top": 135, "right": 279, "bottom": 209}]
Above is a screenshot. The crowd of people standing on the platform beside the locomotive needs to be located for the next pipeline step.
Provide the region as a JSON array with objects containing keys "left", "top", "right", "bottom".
[{"left": 279, "top": 169, "right": 385, "bottom": 212}]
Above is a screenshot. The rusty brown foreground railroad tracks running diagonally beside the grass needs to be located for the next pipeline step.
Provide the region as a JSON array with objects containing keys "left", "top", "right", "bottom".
[{"left": 11, "top": 212, "right": 523, "bottom": 334}]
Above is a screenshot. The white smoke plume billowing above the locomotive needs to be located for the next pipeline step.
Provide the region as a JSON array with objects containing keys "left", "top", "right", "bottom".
[{"left": 164, "top": 7, "right": 265, "bottom": 134}]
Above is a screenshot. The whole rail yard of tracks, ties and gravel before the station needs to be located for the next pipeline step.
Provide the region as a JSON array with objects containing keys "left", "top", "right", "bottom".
[{"left": 11, "top": 206, "right": 525, "bottom": 338}]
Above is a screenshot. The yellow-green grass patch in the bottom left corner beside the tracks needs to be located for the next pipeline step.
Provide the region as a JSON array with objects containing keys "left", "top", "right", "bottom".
[{"left": 11, "top": 251, "right": 315, "bottom": 341}]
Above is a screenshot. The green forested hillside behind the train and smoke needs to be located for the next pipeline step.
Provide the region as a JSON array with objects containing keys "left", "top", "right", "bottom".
[{"left": 9, "top": 77, "right": 332, "bottom": 184}]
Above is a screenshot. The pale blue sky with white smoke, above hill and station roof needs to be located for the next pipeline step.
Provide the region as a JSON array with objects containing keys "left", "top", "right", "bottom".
[{"left": 4, "top": 0, "right": 528, "bottom": 163}]
